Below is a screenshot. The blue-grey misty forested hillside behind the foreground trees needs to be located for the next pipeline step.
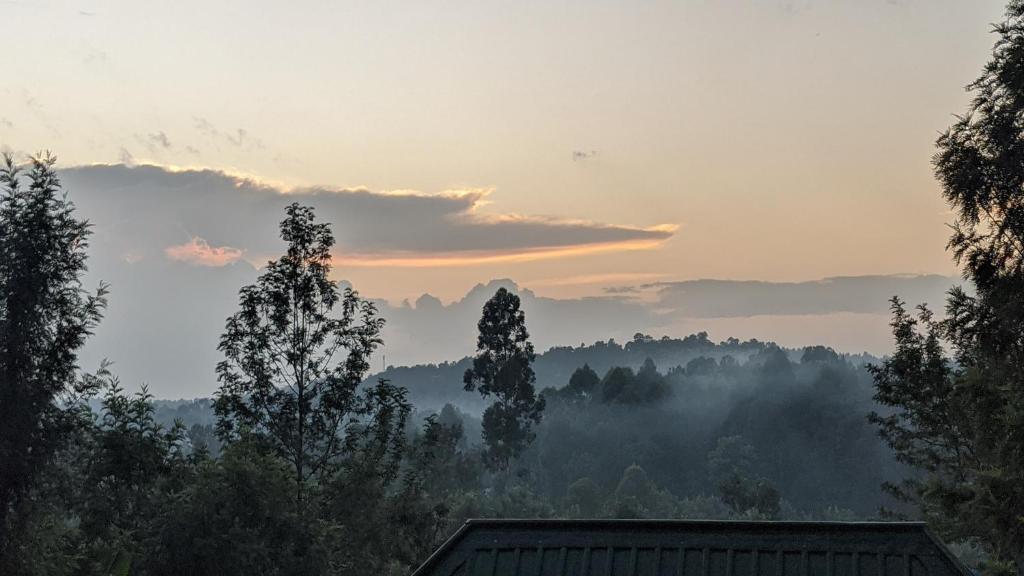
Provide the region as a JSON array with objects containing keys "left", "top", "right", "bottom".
[{"left": 155, "top": 333, "right": 906, "bottom": 519}]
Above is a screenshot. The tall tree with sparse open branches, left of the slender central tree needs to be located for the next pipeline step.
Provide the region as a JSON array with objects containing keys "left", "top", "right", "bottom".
[{"left": 215, "top": 204, "right": 410, "bottom": 507}]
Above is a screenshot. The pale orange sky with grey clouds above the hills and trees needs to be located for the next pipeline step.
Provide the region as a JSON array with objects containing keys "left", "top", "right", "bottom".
[{"left": 0, "top": 0, "right": 1004, "bottom": 396}]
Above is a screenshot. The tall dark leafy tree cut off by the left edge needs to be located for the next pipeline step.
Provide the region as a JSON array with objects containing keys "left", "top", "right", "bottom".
[{"left": 0, "top": 154, "right": 106, "bottom": 560}]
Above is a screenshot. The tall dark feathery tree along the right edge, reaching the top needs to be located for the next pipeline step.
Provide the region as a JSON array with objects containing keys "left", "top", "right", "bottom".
[{"left": 871, "top": 0, "right": 1024, "bottom": 575}]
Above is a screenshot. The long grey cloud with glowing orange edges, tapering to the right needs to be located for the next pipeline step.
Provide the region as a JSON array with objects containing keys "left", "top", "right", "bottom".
[{"left": 62, "top": 165, "right": 675, "bottom": 265}]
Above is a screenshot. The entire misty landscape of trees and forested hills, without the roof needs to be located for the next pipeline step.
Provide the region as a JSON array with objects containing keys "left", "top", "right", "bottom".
[{"left": 9, "top": 0, "right": 1024, "bottom": 576}]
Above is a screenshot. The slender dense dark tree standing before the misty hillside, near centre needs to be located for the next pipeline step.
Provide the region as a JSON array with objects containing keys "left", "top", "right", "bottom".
[{"left": 463, "top": 288, "right": 544, "bottom": 470}]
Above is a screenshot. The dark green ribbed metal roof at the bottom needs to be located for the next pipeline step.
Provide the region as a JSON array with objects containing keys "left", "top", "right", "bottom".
[{"left": 414, "top": 520, "right": 970, "bottom": 576}]
